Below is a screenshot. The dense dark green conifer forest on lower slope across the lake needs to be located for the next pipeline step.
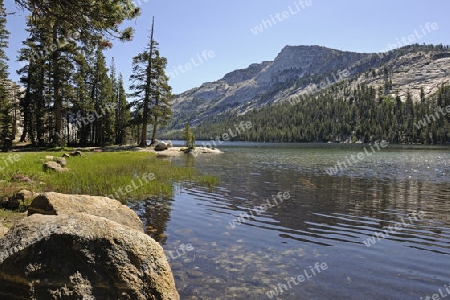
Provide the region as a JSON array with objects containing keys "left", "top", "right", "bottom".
[{"left": 165, "top": 81, "right": 450, "bottom": 144}]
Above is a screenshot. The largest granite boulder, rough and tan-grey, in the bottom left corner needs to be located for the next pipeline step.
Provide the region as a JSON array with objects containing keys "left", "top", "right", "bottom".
[{"left": 0, "top": 213, "right": 179, "bottom": 300}]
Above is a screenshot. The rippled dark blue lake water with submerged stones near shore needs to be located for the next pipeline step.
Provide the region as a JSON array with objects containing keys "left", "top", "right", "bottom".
[{"left": 131, "top": 143, "right": 450, "bottom": 299}]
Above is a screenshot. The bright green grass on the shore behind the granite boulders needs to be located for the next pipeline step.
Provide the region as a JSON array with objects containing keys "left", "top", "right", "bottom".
[{"left": 0, "top": 152, "right": 218, "bottom": 202}]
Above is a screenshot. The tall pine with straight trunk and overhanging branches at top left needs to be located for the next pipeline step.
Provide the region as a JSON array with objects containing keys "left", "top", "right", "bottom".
[{"left": 16, "top": 0, "right": 139, "bottom": 145}]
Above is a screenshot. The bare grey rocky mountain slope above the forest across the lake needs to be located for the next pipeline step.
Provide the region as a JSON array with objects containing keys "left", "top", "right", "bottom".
[{"left": 169, "top": 45, "right": 450, "bottom": 129}]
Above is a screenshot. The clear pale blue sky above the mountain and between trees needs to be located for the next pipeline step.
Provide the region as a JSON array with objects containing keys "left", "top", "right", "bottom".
[{"left": 5, "top": 0, "right": 450, "bottom": 94}]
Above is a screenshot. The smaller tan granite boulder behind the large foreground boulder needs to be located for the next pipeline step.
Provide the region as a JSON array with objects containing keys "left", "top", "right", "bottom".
[{"left": 28, "top": 192, "right": 144, "bottom": 232}]
